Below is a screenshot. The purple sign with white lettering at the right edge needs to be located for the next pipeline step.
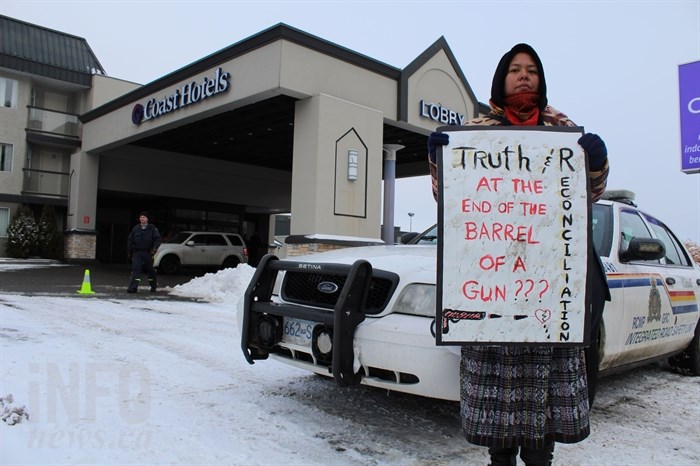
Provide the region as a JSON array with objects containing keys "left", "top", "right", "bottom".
[{"left": 678, "top": 61, "right": 700, "bottom": 173}]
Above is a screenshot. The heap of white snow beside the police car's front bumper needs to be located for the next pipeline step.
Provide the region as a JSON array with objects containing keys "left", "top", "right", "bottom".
[{"left": 169, "top": 264, "right": 255, "bottom": 308}]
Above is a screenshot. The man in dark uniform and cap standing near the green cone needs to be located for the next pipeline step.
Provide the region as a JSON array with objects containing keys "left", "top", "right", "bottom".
[{"left": 126, "top": 212, "right": 160, "bottom": 293}]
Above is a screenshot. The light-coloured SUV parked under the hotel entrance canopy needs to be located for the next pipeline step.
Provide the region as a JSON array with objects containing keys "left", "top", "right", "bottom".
[{"left": 153, "top": 231, "right": 248, "bottom": 274}]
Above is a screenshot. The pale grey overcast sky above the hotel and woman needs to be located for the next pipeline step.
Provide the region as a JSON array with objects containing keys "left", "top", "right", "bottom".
[{"left": 0, "top": 0, "right": 700, "bottom": 243}]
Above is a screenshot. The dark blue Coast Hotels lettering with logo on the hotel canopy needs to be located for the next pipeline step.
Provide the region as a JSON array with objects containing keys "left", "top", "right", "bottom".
[{"left": 131, "top": 68, "right": 231, "bottom": 125}]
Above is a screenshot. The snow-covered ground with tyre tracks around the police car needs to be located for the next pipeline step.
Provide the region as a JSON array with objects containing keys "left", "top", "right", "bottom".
[{"left": 0, "top": 264, "right": 700, "bottom": 466}]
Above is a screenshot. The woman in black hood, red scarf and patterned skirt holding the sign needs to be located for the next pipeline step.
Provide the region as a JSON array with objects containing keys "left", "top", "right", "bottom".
[{"left": 428, "top": 44, "right": 609, "bottom": 466}]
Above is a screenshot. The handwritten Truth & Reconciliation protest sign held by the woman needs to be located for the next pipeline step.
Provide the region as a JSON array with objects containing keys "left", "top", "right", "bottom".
[{"left": 435, "top": 126, "right": 590, "bottom": 346}]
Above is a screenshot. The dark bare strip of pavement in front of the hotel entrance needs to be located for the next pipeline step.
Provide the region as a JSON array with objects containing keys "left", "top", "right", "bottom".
[{"left": 0, "top": 261, "right": 206, "bottom": 300}]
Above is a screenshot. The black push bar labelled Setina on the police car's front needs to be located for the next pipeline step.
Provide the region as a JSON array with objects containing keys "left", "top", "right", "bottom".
[{"left": 241, "top": 254, "right": 372, "bottom": 387}]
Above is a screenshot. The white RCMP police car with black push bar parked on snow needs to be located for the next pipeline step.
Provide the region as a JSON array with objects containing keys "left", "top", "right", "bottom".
[{"left": 238, "top": 191, "right": 700, "bottom": 400}]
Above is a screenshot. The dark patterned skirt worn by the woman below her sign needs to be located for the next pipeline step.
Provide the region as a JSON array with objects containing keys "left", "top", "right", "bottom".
[{"left": 460, "top": 346, "right": 590, "bottom": 449}]
